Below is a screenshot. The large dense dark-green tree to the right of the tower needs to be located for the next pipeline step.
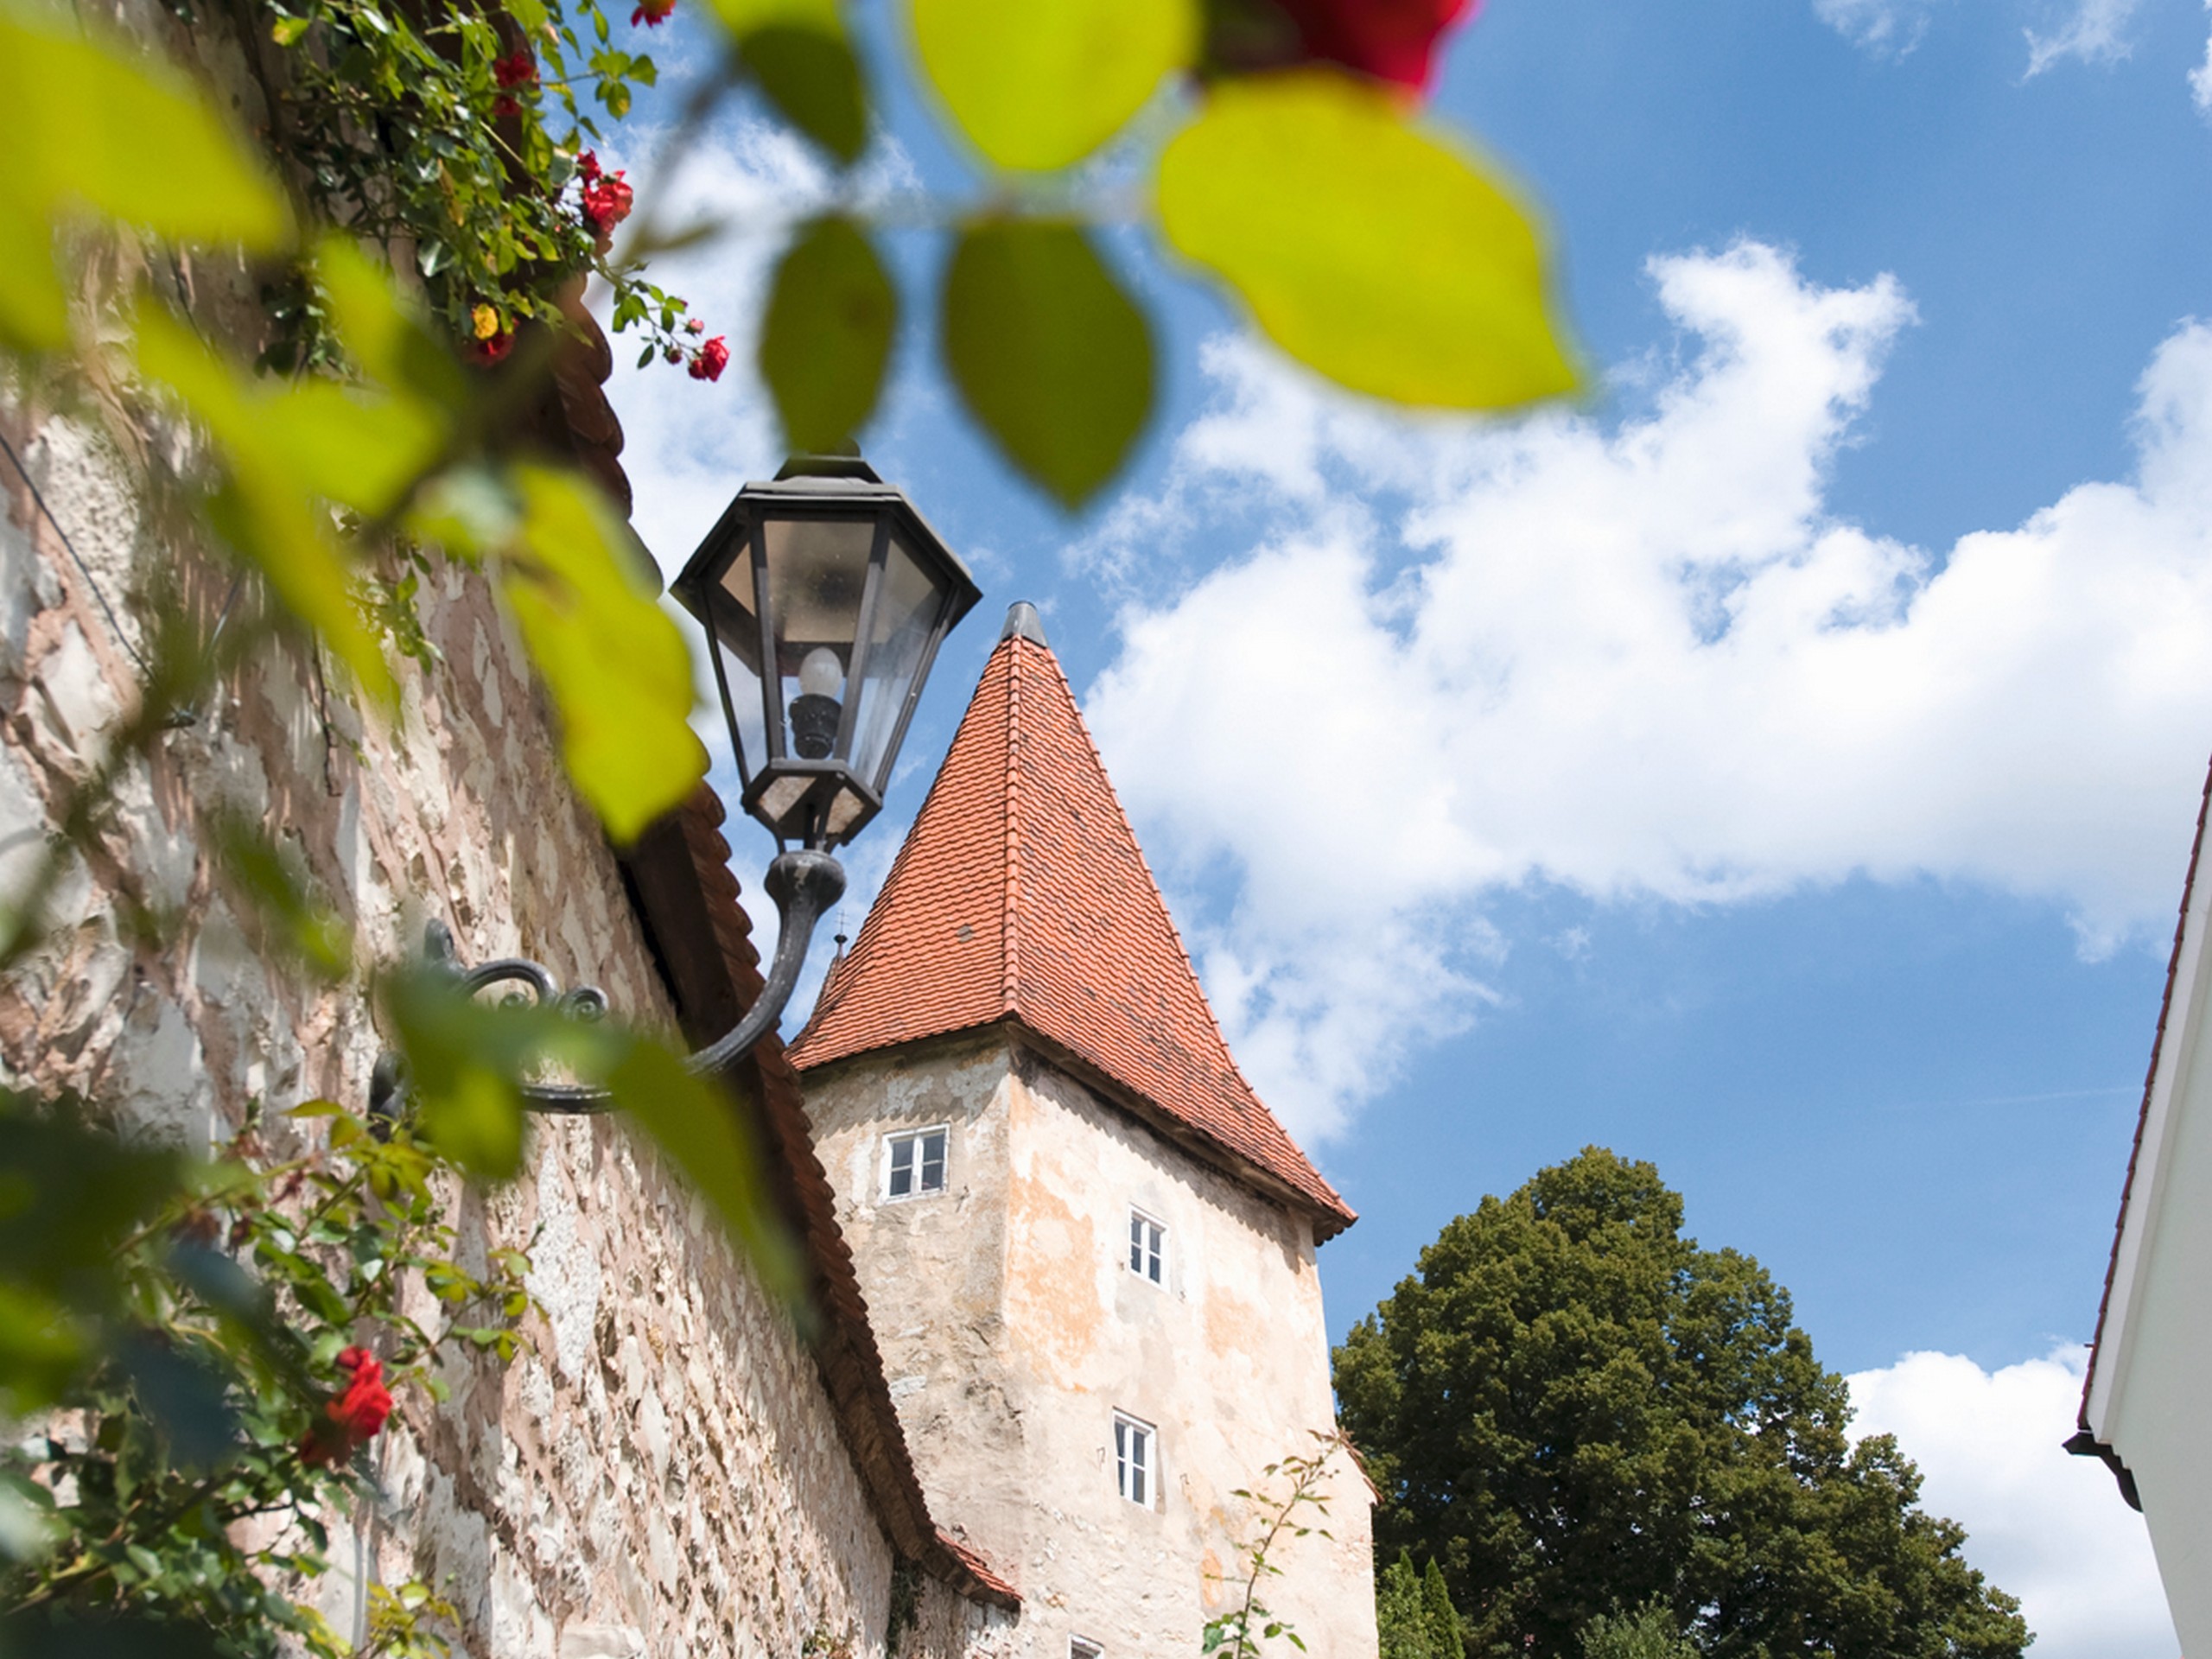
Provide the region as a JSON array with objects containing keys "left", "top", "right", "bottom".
[{"left": 1336, "top": 1148, "right": 2029, "bottom": 1659}]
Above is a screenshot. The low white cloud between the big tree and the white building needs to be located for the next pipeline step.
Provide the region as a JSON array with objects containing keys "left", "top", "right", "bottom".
[{"left": 1849, "top": 1343, "right": 2181, "bottom": 1659}]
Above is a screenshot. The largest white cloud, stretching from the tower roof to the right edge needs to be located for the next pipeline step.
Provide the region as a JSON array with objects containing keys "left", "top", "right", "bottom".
[{"left": 1077, "top": 244, "right": 2212, "bottom": 1137}]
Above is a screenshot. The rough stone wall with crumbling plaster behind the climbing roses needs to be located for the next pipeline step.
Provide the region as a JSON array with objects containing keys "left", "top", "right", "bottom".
[{"left": 0, "top": 360, "right": 1011, "bottom": 1659}]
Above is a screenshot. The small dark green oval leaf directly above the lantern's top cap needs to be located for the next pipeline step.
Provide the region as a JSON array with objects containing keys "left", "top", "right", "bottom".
[{"left": 759, "top": 217, "right": 898, "bottom": 451}]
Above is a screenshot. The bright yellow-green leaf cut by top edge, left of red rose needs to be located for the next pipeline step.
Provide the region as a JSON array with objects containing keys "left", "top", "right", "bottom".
[{"left": 913, "top": 0, "right": 1199, "bottom": 173}]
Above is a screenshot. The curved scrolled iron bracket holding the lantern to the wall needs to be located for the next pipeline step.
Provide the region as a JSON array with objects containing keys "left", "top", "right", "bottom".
[{"left": 370, "top": 849, "right": 845, "bottom": 1119}]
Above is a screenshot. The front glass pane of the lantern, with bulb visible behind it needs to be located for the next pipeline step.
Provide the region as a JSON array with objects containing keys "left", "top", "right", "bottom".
[{"left": 761, "top": 509, "right": 876, "bottom": 759}]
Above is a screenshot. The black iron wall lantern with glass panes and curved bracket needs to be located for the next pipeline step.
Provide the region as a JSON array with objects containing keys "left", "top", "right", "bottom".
[{"left": 385, "top": 455, "right": 982, "bottom": 1113}]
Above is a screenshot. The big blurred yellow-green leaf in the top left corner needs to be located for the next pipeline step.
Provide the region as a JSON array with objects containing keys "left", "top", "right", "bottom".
[{"left": 0, "top": 9, "right": 292, "bottom": 347}]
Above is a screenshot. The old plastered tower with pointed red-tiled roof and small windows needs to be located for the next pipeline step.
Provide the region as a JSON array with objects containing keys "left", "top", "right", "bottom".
[{"left": 791, "top": 604, "right": 1376, "bottom": 1659}]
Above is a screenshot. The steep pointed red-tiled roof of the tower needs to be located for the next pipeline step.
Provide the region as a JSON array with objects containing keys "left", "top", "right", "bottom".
[{"left": 790, "top": 604, "right": 1354, "bottom": 1239}]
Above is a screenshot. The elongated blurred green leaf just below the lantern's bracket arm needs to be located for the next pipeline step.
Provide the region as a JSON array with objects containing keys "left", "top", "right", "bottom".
[{"left": 606, "top": 1039, "right": 805, "bottom": 1303}]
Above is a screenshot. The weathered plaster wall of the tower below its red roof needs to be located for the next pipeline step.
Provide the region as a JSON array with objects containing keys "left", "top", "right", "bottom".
[{"left": 807, "top": 1039, "right": 1376, "bottom": 1659}]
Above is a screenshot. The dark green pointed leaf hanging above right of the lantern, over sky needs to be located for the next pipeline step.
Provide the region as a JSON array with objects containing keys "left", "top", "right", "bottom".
[{"left": 938, "top": 219, "right": 1153, "bottom": 506}]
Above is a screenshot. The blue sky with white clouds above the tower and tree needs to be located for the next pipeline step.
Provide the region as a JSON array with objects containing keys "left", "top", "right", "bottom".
[{"left": 613, "top": 0, "right": 2212, "bottom": 1659}]
